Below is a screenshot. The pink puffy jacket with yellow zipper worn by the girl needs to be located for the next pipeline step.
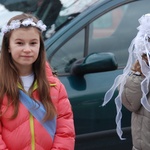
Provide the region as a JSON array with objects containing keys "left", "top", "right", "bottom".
[{"left": 0, "top": 64, "right": 75, "bottom": 150}]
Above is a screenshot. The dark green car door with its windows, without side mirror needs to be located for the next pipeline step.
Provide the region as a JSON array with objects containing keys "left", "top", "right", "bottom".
[{"left": 46, "top": 0, "right": 150, "bottom": 150}]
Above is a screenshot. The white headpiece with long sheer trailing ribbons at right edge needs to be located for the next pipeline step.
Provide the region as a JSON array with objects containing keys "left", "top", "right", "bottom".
[{"left": 102, "top": 14, "right": 150, "bottom": 139}]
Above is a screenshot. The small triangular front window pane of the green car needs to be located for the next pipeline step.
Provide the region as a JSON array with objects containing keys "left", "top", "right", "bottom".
[{"left": 50, "top": 29, "right": 85, "bottom": 75}]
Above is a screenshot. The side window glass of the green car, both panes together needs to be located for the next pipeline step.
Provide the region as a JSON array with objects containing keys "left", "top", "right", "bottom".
[{"left": 51, "top": 1, "right": 150, "bottom": 74}]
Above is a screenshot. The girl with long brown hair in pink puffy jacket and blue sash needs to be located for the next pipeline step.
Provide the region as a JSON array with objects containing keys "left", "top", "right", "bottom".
[{"left": 0, "top": 14, "right": 75, "bottom": 150}]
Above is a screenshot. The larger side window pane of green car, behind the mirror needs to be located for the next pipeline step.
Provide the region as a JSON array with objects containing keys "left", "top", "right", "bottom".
[{"left": 89, "top": 1, "right": 150, "bottom": 67}]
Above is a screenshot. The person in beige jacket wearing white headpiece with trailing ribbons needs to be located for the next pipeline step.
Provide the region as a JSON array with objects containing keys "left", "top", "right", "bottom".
[{"left": 103, "top": 14, "right": 150, "bottom": 150}]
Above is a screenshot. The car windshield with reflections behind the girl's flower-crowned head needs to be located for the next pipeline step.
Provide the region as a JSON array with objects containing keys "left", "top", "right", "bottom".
[{"left": 0, "top": 0, "right": 104, "bottom": 39}]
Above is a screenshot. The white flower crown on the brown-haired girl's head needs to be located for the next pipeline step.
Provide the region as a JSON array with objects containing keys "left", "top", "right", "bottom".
[{"left": 1, "top": 18, "right": 46, "bottom": 34}]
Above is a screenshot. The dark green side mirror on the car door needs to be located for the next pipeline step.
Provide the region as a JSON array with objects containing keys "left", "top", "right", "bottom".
[{"left": 70, "top": 53, "right": 118, "bottom": 76}]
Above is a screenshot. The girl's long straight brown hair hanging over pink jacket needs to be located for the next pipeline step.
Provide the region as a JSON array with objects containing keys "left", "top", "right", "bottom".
[{"left": 0, "top": 14, "right": 56, "bottom": 121}]
